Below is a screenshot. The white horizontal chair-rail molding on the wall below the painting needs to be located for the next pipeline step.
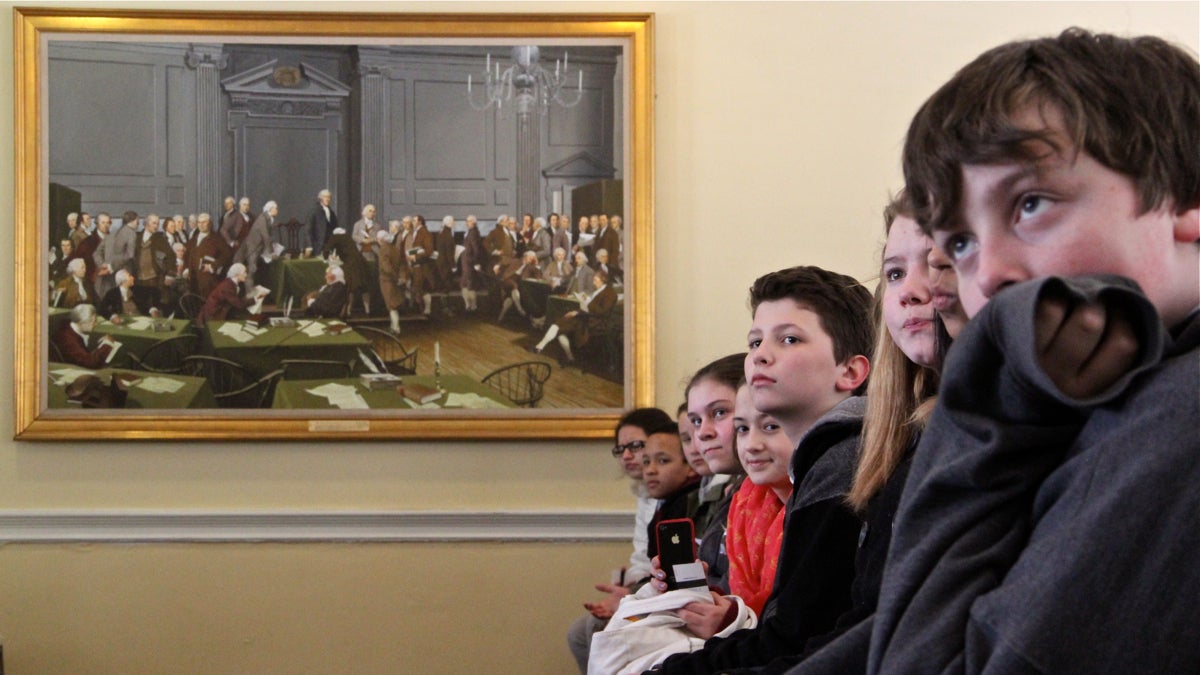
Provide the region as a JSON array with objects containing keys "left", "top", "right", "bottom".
[{"left": 0, "top": 509, "right": 634, "bottom": 543}]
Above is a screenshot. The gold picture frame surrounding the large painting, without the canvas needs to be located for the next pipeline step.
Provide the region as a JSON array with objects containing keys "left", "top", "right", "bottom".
[{"left": 13, "top": 7, "right": 654, "bottom": 441}]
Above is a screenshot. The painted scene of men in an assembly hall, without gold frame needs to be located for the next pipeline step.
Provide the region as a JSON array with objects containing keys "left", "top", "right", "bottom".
[{"left": 44, "top": 41, "right": 636, "bottom": 414}]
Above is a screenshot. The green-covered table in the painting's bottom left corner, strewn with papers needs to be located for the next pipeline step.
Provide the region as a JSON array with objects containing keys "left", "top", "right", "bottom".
[{"left": 46, "top": 363, "right": 217, "bottom": 410}]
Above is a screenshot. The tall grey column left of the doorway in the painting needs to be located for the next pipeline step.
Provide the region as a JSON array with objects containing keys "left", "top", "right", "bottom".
[{"left": 184, "top": 44, "right": 229, "bottom": 218}]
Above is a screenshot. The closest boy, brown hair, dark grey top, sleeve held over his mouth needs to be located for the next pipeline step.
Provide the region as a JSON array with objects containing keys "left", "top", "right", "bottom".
[{"left": 869, "top": 29, "right": 1200, "bottom": 673}]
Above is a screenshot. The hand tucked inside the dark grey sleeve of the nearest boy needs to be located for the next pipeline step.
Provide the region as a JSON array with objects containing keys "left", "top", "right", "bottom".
[{"left": 1034, "top": 291, "right": 1139, "bottom": 399}]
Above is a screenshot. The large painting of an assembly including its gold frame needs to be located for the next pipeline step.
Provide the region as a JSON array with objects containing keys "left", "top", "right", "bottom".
[{"left": 13, "top": 7, "right": 654, "bottom": 441}]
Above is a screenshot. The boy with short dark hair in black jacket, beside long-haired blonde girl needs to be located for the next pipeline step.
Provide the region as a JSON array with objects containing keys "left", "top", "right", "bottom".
[{"left": 659, "top": 267, "right": 872, "bottom": 673}]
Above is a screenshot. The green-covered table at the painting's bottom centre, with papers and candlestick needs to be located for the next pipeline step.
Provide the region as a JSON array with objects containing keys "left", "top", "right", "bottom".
[{"left": 271, "top": 375, "right": 515, "bottom": 410}]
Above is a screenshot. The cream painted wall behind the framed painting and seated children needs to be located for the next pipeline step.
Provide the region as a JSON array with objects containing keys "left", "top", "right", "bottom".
[{"left": 0, "top": 0, "right": 1200, "bottom": 675}]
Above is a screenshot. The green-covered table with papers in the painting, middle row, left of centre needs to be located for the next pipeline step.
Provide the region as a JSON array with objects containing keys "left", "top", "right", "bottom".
[{"left": 204, "top": 318, "right": 371, "bottom": 377}]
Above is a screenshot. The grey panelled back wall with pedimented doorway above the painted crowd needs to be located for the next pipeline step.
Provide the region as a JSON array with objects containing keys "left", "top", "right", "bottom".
[{"left": 47, "top": 42, "right": 624, "bottom": 230}]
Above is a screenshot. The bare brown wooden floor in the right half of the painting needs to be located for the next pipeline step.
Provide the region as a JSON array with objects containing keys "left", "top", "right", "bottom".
[{"left": 350, "top": 307, "right": 625, "bottom": 408}]
